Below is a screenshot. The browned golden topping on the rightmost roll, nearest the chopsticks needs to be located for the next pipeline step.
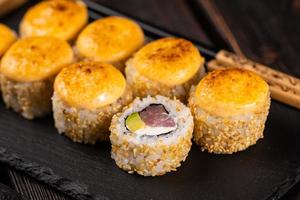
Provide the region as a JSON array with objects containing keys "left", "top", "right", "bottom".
[{"left": 195, "top": 68, "right": 269, "bottom": 117}]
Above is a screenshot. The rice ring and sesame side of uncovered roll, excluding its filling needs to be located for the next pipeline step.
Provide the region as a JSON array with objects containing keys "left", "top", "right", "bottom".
[{"left": 110, "top": 96, "right": 194, "bottom": 176}]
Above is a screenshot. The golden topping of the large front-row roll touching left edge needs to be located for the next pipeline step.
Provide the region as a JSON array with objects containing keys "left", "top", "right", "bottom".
[{"left": 1, "top": 36, "right": 73, "bottom": 82}]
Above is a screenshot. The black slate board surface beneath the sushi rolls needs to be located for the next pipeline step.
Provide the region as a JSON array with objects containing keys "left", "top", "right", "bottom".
[{"left": 0, "top": 0, "right": 300, "bottom": 200}]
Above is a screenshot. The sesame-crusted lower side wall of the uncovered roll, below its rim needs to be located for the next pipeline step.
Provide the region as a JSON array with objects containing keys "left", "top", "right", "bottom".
[{"left": 110, "top": 133, "right": 193, "bottom": 176}]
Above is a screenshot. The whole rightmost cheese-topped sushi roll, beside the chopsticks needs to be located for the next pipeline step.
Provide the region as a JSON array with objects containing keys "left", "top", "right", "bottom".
[{"left": 189, "top": 68, "right": 270, "bottom": 154}]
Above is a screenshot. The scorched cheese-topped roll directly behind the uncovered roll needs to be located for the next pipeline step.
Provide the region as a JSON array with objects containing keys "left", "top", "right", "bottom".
[{"left": 125, "top": 38, "right": 205, "bottom": 102}]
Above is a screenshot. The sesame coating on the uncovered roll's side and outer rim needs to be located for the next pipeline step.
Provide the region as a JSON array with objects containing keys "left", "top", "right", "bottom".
[{"left": 110, "top": 97, "right": 194, "bottom": 176}]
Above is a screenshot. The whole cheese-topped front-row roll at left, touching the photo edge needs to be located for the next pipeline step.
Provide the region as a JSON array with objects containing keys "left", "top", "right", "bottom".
[{"left": 1, "top": 36, "right": 73, "bottom": 119}]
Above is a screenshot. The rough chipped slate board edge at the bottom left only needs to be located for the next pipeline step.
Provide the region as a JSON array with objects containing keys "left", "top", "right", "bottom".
[{"left": 0, "top": 147, "right": 109, "bottom": 200}]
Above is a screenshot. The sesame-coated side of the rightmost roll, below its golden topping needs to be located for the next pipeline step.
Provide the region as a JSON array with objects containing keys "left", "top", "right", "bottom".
[{"left": 189, "top": 87, "right": 270, "bottom": 154}]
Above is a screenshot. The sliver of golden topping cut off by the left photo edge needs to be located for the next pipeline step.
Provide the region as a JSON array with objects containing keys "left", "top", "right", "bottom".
[{"left": 0, "top": 23, "right": 17, "bottom": 57}]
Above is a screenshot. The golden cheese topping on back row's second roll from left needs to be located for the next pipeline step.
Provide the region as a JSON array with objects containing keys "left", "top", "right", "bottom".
[{"left": 76, "top": 16, "right": 144, "bottom": 63}]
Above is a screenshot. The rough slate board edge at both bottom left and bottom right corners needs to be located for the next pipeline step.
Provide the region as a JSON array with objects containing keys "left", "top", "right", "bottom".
[{"left": 0, "top": 144, "right": 300, "bottom": 200}]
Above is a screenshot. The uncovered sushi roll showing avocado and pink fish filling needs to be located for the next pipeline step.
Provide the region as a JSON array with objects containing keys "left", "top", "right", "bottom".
[{"left": 110, "top": 96, "right": 194, "bottom": 176}]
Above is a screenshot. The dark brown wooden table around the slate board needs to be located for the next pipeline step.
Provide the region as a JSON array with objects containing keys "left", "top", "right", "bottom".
[{"left": 0, "top": 0, "right": 300, "bottom": 200}]
